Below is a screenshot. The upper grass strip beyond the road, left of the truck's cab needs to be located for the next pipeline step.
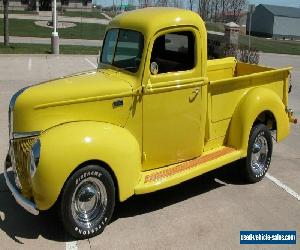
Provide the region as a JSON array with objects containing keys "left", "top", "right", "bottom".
[{"left": 0, "top": 19, "right": 106, "bottom": 40}]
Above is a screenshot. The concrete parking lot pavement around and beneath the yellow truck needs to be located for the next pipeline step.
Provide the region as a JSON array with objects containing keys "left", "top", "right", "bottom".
[{"left": 0, "top": 54, "right": 300, "bottom": 249}]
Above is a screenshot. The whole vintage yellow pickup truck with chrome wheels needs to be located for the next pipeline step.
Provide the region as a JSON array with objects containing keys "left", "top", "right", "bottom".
[{"left": 4, "top": 8, "right": 296, "bottom": 239}]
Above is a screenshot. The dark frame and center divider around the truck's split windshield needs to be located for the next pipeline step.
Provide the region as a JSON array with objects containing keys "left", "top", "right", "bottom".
[{"left": 98, "top": 27, "right": 145, "bottom": 75}]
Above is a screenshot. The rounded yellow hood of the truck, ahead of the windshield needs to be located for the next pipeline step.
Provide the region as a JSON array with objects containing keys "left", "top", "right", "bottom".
[{"left": 13, "top": 70, "right": 132, "bottom": 132}]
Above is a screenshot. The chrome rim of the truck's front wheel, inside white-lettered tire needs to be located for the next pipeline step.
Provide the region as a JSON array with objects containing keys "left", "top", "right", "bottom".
[{"left": 71, "top": 177, "right": 107, "bottom": 228}]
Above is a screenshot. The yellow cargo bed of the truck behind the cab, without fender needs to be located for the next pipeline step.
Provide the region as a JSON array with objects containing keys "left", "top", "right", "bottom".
[{"left": 205, "top": 58, "right": 290, "bottom": 151}]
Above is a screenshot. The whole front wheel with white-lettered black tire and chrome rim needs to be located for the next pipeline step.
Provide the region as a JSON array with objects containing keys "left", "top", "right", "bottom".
[{"left": 60, "top": 165, "right": 115, "bottom": 239}]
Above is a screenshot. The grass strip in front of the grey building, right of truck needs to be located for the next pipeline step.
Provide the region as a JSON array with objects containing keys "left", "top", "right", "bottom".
[{"left": 240, "top": 35, "right": 300, "bottom": 55}]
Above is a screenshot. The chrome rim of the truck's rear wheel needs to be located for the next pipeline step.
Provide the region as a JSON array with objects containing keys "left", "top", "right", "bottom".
[{"left": 251, "top": 135, "right": 269, "bottom": 176}]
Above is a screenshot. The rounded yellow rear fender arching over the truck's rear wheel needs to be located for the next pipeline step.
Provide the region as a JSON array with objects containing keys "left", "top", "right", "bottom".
[{"left": 228, "top": 87, "right": 290, "bottom": 156}]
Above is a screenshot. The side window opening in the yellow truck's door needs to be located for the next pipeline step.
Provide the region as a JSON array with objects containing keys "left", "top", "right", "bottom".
[{"left": 151, "top": 31, "right": 195, "bottom": 74}]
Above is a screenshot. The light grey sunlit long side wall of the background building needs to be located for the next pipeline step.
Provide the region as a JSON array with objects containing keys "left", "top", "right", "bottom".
[{"left": 273, "top": 16, "right": 300, "bottom": 38}]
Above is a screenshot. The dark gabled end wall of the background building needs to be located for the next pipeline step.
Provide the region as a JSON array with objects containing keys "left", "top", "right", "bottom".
[{"left": 247, "top": 5, "right": 274, "bottom": 37}]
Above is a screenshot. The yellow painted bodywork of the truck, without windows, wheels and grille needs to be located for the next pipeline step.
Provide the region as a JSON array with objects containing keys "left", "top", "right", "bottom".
[{"left": 7, "top": 8, "right": 289, "bottom": 210}]
